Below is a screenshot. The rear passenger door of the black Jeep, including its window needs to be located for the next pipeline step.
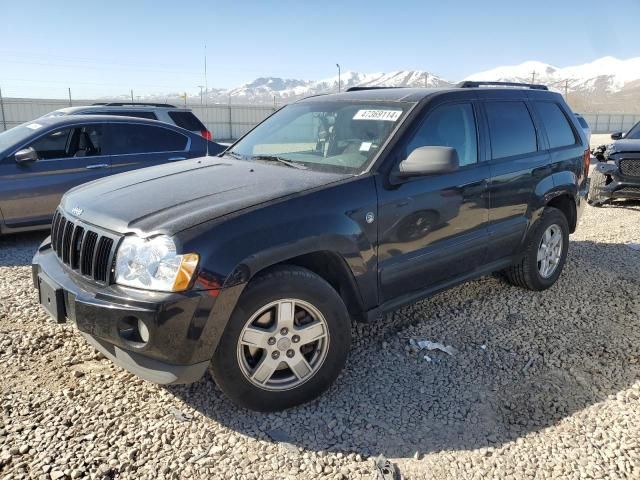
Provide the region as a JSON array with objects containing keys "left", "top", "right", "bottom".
[{"left": 481, "top": 92, "right": 553, "bottom": 262}]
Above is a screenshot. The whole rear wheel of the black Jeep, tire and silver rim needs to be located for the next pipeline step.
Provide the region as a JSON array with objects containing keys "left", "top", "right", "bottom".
[{"left": 504, "top": 207, "right": 569, "bottom": 291}]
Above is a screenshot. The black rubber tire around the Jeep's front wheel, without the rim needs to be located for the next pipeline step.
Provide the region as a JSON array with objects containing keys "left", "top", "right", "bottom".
[{"left": 211, "top": 268, "right": 351, "bottom": 411}]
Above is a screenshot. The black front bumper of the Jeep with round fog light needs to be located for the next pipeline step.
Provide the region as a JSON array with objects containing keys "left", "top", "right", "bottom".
[{"left": 32, "top": 240, "right": 217, "bottom": 384}]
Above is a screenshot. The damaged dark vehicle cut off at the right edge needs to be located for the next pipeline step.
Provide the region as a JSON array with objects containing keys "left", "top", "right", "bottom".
[{"left": 589, "top": 122, "right": 640, "bottom": 207}]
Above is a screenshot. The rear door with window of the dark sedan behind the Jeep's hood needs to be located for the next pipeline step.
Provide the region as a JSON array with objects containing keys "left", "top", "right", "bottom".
[{"left": 105, "top": 122, "right": 194, "bottom": 173}]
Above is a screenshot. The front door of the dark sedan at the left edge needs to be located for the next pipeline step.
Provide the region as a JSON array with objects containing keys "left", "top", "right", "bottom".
[{"left": 0, "top": 124, "right": 110, "bottom": 228}]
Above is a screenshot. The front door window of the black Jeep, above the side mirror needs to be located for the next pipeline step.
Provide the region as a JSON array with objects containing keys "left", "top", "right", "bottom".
[{"left": 406, "top": 103, "right": 478, "bottom": 167}]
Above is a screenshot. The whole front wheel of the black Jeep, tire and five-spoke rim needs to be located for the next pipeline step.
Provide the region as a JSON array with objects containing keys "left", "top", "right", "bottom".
[{"left": 211, "top": 265, "right": 351, "bottom": 412}]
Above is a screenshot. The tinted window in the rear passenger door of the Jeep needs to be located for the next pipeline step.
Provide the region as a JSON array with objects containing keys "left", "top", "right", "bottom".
[{"left": 485, "top": 102, "right": 538, "bottom": 159}]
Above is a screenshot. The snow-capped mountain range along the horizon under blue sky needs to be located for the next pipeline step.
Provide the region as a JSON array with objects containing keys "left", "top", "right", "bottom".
[{"left": 142, "top": 57, "right": 640, "bottom": 113}]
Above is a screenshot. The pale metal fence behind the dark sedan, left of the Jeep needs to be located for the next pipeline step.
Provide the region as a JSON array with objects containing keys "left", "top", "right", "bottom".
[{"left": 0, "top": 98, "right": 278, "bottom": 140}]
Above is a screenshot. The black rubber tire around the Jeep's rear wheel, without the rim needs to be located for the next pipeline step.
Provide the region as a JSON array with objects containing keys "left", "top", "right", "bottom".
[{"left": 527, "top": 208, "right": 569, "bottom": 290}]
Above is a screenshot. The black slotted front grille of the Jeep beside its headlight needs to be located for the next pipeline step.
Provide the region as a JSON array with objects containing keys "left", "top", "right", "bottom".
[{"left": 51, "top": 210, "right": 119, "bottom": 283}]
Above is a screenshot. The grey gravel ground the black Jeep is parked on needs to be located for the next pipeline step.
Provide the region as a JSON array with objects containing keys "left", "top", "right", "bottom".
[{"left": 0, "top": 198, "right": 640, "bottom": 480}]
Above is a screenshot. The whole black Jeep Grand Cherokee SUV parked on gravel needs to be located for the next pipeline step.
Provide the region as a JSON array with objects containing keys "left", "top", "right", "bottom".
[{"left": 33, "top": 83, "right": 589, "bottom": 410}]
